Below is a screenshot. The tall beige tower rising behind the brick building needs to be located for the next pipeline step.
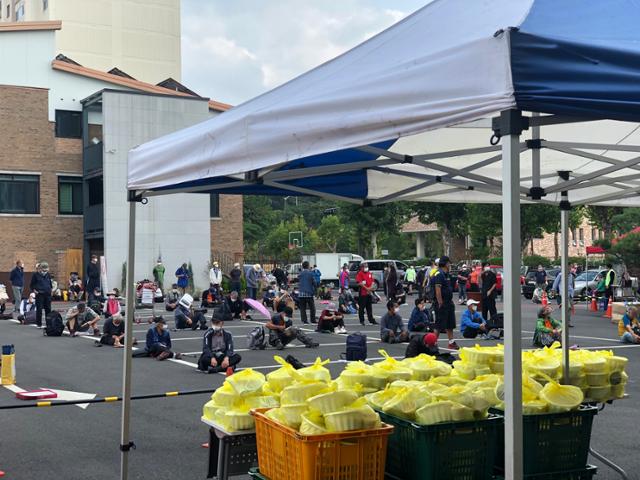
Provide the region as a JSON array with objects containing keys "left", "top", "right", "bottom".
[{"left": 0, "top": 0, "right": 181, "bottom": 84}]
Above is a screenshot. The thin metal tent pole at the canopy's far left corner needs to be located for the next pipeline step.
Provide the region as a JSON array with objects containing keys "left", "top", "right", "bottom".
[{"left": 120, "top": 192, "right": 137, "bottom": 480}]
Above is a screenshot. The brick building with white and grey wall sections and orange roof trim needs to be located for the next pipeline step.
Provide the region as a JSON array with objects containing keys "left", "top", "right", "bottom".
[{"left": 0, "top": 22, "right": 243, "bottom": 298}]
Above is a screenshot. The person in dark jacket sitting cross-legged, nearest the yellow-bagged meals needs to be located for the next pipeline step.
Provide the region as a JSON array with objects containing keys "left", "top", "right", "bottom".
[{"left": 198, "top": 315, "right": 242, "bottom": 376}]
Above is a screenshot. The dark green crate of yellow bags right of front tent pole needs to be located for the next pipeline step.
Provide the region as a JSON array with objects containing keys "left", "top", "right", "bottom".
[{"left": 496, "top": 406, "right": 598, "bottom": 478}]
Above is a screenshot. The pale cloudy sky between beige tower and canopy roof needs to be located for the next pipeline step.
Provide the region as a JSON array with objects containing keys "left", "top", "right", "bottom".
[{"left": 182, "top": 0, "right": 429, "bottom": 105}]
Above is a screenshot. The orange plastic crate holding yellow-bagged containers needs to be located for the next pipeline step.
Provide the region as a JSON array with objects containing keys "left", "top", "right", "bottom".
[{"left": 251, "top": 408, "right": 393, "bottom": 480}]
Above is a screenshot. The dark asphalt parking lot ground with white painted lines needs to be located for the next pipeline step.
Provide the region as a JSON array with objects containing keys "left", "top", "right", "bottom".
[{"left": 0, "top": 297, "right": 640, "bottom": 480}]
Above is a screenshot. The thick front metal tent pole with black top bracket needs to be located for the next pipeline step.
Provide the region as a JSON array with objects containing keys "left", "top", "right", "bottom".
[{"left": 500, "top": 110, "right": 523, "bottom": 480}]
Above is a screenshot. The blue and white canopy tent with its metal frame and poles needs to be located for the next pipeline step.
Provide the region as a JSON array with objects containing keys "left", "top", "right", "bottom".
[{"left": 122, "top": 0, "right": 640, "bottom": 479}]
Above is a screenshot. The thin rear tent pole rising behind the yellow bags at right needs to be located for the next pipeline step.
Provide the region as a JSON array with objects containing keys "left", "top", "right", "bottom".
[{"left": 558, "top": 171, "right": 572, "bottom": 384}]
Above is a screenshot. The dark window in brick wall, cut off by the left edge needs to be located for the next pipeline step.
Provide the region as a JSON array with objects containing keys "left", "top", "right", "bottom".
[{"left": 0, "top": 174, "right": 40, "bottom": 214}]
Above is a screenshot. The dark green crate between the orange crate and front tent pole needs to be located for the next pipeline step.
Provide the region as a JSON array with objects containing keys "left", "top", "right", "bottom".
[{"left": 378, "top": 412, "right": 504, "bottom": 480}]
